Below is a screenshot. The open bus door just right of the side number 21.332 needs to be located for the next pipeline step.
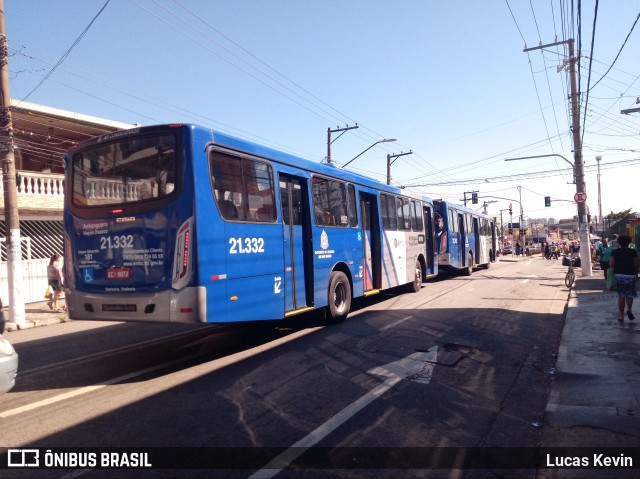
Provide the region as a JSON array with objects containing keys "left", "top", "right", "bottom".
[{"left": 279, "top": 174, "right": 313, "bottom": 312}]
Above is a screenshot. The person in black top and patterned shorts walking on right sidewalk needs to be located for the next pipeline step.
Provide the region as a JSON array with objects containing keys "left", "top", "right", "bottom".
[{"left": 609, "top": 235, "right": 638, "bottom": 321}]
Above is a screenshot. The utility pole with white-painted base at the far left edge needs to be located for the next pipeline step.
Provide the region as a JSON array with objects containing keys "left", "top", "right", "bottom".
[{"left": 0, "top": 0, "right": 25, "bottom": 326}]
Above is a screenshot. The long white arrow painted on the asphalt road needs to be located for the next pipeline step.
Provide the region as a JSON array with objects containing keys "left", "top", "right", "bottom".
[{"left": 249, "top": 346, "right": 438, "bottom": 479}]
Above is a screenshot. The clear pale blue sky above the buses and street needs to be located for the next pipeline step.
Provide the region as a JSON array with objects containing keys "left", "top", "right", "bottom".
[{"left": 5, "top": 0, "right": 640, "bottom": 229}]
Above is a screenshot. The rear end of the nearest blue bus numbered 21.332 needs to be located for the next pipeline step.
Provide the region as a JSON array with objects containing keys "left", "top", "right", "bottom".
[{"left": 64, "top": 127, "right": 199, "bottom": 321}]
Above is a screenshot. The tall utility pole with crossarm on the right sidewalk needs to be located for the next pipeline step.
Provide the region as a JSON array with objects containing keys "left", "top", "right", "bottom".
[{"left": 524, "top": 38, "right": 593, "bottom": 276}]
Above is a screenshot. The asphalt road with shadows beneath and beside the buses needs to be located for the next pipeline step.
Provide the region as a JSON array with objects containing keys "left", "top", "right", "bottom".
[{"left": 0, "top": 258, "right": 568, "bottom": 478}]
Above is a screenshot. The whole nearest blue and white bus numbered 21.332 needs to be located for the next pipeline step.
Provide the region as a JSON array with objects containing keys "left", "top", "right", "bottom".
[{"left": 64, "top": 124, "right": 438, "bottom": 323}]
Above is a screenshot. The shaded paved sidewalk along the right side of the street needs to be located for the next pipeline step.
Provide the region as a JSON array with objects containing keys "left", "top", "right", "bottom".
[{"left": 542, "top": 269, "right": 640, "bottom": 452}]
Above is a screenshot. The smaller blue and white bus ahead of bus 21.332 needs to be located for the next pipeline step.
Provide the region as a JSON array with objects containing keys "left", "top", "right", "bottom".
[{"left": 433, "top": 200, "right": 497, "bottom": 275}]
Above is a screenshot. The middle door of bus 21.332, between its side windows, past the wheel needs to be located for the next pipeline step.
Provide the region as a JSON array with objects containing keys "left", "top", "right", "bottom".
[{"left": 360, "top": 193, "right": 382, "bottom": 292}]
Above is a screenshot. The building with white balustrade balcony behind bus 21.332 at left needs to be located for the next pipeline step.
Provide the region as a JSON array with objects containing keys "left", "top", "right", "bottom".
[{"left": 0, "top": 100, "right": 136, "bottom": 303}]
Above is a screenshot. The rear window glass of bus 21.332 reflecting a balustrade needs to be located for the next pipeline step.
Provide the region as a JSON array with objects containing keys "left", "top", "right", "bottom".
[{"left": 71, "top": 134, "right": 177, "bottom": 207}]
